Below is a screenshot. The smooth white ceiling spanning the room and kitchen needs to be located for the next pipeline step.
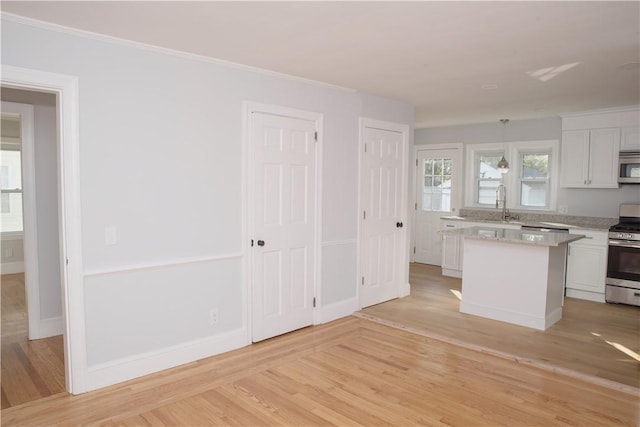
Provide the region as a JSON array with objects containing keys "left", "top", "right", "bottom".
[{"left": 0, "top": 0, "right": 640, "bottom": 127}]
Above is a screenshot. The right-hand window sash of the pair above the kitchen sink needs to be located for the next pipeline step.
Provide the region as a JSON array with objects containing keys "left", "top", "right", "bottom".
[{"left": 518, "top": 152, "right": 550, "bottom": 209}]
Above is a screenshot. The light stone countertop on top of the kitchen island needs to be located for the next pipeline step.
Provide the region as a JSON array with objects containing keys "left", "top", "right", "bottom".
[{"left": 442, "top": 226, "right": 585, "bottom": 246}]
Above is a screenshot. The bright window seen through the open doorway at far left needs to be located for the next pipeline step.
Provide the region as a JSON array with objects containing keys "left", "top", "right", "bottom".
[{"left": 0, "top": 113, "right": 23, "bottom": 233}]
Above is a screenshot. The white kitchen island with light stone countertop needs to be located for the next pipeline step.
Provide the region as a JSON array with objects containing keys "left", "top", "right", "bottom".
[{"left": 444, "top": 227, "right": 584, "bottom": 330}]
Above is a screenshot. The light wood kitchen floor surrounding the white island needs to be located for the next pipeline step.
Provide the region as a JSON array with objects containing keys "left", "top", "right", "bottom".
[{"left": 361, "top": 264, "right": 640, "bottom": 389}]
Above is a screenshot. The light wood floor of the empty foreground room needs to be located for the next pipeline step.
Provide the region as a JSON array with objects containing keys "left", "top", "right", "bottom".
[{"left": 2, "top": 317, "right": 639, "bottom": 426}]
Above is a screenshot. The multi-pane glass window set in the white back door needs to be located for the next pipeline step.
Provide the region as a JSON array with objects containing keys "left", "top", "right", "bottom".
[{"left": 422, "top": 158, "right": 452, "bottom": 212}]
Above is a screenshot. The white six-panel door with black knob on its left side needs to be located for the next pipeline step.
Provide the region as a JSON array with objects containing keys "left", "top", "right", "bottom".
[{"left": 250, "top": 112, "right": 317, "bottom": 342}]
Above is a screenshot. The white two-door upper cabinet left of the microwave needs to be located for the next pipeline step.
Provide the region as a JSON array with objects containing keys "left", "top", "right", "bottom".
[{"left": 560, "top": 128, "right": 620, "bottom": 188}]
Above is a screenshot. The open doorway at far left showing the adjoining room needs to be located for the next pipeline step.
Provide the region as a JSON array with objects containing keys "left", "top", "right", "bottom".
[{"left": 0, "top": 86, "right": 66, "bottom": 409}]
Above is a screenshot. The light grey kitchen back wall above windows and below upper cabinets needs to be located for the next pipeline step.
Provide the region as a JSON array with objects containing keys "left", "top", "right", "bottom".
[{"left": 415, "top": 117, "right": 640, "bottom": 218}]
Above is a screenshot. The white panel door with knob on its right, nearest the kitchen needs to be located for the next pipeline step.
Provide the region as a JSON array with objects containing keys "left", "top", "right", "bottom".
[{"left": 360, "top": 122, "right": 408, "bottom": 307}]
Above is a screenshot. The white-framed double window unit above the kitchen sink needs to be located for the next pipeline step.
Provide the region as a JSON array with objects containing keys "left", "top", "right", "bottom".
[{"left": 465, "top": 140, "right": 559, "bottom": 211}]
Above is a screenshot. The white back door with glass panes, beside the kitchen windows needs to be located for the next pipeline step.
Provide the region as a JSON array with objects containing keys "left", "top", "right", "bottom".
[{"left": 413, "top": 149, "right": 462, "bottom": 265}]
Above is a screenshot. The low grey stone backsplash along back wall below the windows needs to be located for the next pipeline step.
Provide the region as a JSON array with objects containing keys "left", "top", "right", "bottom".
[{"left": 458, "top": 208, "right": 618, "bottom": 228}]
